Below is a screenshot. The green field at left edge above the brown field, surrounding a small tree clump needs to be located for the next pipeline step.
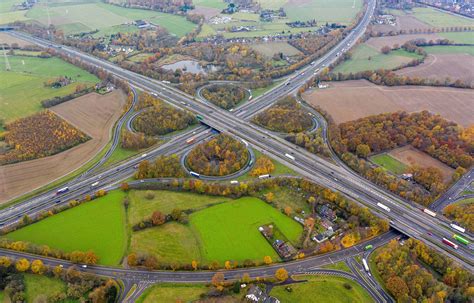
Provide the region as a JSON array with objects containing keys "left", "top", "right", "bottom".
[{"left": 0, "top": 56, "right": 99, "bottom": 122}]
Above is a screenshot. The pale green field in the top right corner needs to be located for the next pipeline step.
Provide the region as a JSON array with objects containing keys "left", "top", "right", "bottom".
[{"left": 412, "top": 7, "right": 474, "bottom": 27}]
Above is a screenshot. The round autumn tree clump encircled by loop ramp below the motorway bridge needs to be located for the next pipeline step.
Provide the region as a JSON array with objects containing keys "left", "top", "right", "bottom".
[{"left": 186, "top": 133, "right": 249, "bottom": 176}]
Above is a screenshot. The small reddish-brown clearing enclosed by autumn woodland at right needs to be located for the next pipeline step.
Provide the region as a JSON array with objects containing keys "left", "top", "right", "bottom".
[{"left": 389, "top": 145, "right": 454, "bottom": 183}]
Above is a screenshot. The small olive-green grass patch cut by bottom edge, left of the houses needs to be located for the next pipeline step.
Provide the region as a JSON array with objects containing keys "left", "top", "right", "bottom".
[{"left": 136, "top": 283, "right": 208, "bottom": 303}]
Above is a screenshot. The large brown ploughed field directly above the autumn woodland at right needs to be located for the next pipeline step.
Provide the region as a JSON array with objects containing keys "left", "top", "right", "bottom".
[{"left": 303, "top": 80, "right": 474, "bottom": 127}]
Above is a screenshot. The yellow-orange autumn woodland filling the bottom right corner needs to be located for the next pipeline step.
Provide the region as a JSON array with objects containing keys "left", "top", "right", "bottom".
[{"left": 374, "top": 239, "right": 474, "bottom": 303}]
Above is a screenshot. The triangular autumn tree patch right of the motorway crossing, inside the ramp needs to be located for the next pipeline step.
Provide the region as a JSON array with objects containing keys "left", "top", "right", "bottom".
[{"left": 252, "top": 96, "right": 313, "bottom": 133}]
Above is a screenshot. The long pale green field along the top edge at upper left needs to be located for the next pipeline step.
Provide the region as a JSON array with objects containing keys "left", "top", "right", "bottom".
[{"left": 19, "top": 1, "right": 195, "bottom": 37}]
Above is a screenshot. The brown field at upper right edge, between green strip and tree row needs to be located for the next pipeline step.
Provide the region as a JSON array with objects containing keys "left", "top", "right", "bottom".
[{"left": 396, "top": 54, "right": 474, "bottom": 85}]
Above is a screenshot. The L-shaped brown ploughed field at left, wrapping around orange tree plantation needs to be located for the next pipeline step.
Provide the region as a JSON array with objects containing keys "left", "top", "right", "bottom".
[{"left": 0, "top": 90, "right": 126, "bottom": 203}]
